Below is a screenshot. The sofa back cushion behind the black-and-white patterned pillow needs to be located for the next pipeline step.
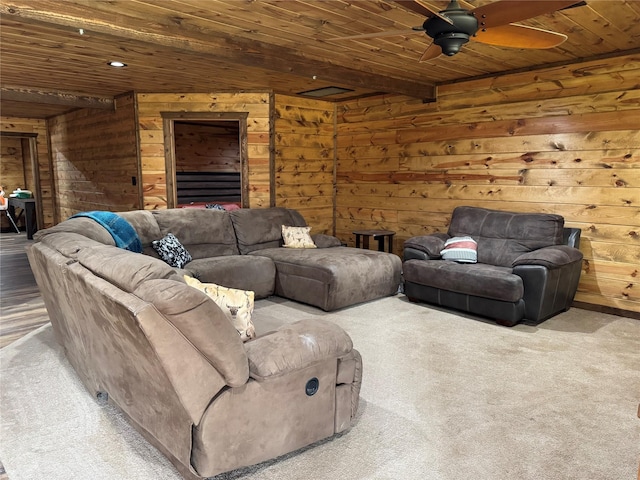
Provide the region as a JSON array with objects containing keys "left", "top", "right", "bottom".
[{"left": 150, "top": 208, "right": 238, "bottom": 260}]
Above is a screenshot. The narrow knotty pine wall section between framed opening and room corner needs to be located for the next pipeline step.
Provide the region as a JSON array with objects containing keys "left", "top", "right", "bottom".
[{"left": 274, "top": 95, "right": 336, "bottom": 234}]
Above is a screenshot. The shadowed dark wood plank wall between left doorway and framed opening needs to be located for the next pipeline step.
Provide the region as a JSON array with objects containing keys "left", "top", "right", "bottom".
[{"left": 49, "top": 94, "right": 140, "bottom": 223}]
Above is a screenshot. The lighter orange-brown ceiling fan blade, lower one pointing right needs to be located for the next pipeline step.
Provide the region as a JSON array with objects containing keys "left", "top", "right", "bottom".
[{"left": 471, "top": 24, "right": 567, "bottom": 48}]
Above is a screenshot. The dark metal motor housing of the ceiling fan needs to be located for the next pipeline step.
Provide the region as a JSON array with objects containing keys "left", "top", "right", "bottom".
[{"left": 422, "top": 2, "right": 478, "bottom": 56}]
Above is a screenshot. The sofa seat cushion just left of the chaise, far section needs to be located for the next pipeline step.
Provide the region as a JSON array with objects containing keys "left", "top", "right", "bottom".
[{"left": 185, "top": 255, "right": 276, "bottom": 298}]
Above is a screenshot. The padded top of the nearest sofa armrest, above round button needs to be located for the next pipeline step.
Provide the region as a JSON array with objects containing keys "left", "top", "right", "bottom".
[{"left": 244, "top": 320, "right": 353, "bottom": 380}]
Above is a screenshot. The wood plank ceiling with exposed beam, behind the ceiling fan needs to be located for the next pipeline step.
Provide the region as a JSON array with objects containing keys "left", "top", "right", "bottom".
[{"left": 0, "top": 0, "right": 640, "bottom": 118}]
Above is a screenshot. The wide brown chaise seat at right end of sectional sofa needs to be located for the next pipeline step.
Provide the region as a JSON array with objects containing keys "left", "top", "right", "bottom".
[{"left": 250, "top": 247, "right": 402, "bottom": 311}]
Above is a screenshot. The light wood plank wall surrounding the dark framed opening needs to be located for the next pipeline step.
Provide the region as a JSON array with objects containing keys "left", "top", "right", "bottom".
[{"left": 136, "top": 92, "right": 271, "bottom": 210}]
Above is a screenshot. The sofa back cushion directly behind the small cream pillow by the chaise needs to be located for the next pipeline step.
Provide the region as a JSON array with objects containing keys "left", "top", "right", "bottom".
[{"left": 229, "top": 207, "right": 307, "bottom": 254}]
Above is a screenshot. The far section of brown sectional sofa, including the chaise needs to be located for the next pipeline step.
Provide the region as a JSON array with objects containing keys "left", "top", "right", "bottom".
[{"left": 119, "top": 207, "right": 402, "bottom": 311}]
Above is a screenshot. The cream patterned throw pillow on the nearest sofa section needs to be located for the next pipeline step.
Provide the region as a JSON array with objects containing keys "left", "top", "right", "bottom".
[{"left": 184, "top": 275, "right": 256, "bottom": 342}]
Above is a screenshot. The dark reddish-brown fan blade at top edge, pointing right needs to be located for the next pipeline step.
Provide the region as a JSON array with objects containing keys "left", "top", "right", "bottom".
[{"left": 472, "top": 0, "right": 580, "bottom": 29}]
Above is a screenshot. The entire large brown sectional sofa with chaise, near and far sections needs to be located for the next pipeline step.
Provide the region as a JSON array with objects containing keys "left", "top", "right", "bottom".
[{"left": 27, "top": 208, "right": 400, "bottom": 478}]
